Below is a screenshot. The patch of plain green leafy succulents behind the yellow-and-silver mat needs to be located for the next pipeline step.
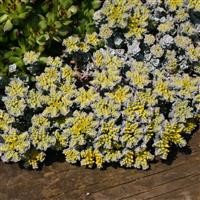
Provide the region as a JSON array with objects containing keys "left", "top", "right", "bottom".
[{"left": 0, "top": 0, "right": 101, "bottom": 77}]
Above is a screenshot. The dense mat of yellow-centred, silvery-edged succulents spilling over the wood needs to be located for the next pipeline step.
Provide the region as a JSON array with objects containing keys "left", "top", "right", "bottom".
[{"left": 0, "top": 0, "right": 200, "bottom": 170}]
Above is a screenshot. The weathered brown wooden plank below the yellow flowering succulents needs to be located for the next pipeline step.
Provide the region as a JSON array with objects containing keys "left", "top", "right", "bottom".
[{"left": 0, "top": 132, "right": 200, "bottom": 200}]
